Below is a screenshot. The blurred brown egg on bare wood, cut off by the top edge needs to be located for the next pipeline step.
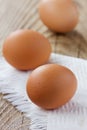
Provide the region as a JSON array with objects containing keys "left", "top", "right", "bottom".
[{"left": 39, "top": 0, "right": 79, "bottom": 33}]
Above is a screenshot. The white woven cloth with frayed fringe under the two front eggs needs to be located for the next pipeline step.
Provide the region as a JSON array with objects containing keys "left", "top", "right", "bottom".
[{"left": 0, "top": 53, "right": 87, "bottom": 130}]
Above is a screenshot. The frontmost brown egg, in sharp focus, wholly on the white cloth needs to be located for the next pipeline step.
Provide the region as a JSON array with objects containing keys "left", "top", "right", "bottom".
[{"left": 27, "top": 64, "right": 77, "bottom": 109}]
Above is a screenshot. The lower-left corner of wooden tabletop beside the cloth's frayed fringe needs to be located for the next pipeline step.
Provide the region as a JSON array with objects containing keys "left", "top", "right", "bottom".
[{"left": 0, "top": 94, "right": 30, "bottom": 130}]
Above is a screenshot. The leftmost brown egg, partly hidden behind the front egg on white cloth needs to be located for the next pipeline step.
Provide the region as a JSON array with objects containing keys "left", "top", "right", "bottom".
[{"left": 3, "top": 30, "right": 51, "bottom": 70}]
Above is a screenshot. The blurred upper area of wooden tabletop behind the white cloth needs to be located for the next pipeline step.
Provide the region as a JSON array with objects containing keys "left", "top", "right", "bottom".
[{"left": 0, "top": 0, "right": 87, "bottom": 59}]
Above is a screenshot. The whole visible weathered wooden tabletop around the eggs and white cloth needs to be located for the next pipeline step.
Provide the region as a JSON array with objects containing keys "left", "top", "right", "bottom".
[{"left": 0, "top": 0, "right": 87, "bottom": 130}]
